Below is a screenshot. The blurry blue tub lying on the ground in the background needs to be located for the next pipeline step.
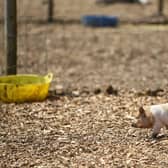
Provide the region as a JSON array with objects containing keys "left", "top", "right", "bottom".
[{"left": 81, "top": 15, "right": 119, "bottom": 27}]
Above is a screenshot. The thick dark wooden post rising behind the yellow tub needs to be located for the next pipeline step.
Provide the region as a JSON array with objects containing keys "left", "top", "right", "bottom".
[{"left": 4, "top": 0, "right": 17, "bottom": 75}]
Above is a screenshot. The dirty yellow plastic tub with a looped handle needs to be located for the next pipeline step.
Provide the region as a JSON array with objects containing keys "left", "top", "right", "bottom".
[{"left": 0, "top": 73, "right": 53, "bottom": 103}]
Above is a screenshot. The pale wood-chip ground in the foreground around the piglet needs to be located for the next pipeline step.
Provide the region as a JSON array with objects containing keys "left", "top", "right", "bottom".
[{"left": 0, "top": 91, "right": 168, "bottom": 167}]
